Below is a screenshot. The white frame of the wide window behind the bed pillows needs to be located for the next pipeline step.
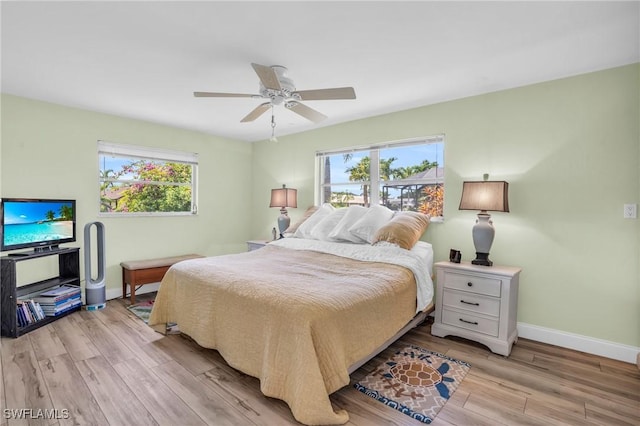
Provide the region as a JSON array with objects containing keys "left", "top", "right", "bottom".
[{"left": 315, "top": 134, "right": 446, "bottom": 222}]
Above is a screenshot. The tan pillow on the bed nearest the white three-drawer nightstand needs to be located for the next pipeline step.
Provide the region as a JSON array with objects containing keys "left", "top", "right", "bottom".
[{"left": 373, "top": 212, "right": 429, "bottom": 250}]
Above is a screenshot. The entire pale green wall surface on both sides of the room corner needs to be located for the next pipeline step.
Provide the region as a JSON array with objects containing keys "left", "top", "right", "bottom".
[{"left": 0, "top": 64, "right": 640, "bottom": 347}]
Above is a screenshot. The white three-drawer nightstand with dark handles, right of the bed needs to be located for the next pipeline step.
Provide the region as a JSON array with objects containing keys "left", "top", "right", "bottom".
[{"left": 431, "top": 262, "right": 521, "bottom": 356}]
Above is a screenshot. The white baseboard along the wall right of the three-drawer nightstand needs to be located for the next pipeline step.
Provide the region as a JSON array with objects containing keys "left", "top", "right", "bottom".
[{"left": 518, "top": 322, "right": 640, "bottom": 364}]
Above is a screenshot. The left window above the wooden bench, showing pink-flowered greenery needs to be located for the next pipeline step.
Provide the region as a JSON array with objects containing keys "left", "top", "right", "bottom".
[{"left": 98, "top": 141, "right": 198, "bottom": 216}]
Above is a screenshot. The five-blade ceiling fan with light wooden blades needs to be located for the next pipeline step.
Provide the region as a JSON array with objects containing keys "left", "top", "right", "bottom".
[{"left": 193, "top": 63, "right": 356, "bottom": 123}]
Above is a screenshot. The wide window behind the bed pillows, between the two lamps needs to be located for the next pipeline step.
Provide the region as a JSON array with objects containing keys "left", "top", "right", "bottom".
[{"left": 316, "top": 135, "right": 444, "bottom": 218}]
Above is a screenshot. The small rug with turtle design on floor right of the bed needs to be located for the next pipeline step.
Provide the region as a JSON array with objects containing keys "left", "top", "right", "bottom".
[{"left": 354, "top": 346, "right": 471, "bottom": 423}]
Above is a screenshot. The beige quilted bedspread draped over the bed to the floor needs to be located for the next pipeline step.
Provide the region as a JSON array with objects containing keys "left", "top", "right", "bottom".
[{"left": 149, "top": 246, "right": 416, "bottom": 425}]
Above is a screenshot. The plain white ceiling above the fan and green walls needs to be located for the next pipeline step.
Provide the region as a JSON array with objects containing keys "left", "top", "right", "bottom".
[{"left": 1, "top": 1, "right": 640, "bottom": 141}]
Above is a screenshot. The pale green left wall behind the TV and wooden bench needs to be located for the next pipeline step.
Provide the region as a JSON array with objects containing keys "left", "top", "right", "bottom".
[{"left": 0, "top": 95, "right": 252, "bottom": 295}]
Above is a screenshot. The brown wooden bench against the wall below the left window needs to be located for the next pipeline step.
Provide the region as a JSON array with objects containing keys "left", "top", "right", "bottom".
[{"left": 120, "top": 254, "right": 204, "bottom": 305}]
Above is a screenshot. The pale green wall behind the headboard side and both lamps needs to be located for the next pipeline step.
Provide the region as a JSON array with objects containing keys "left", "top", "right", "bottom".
[{"left": 252, "top": 64, "right": 640, "bottom": 347}]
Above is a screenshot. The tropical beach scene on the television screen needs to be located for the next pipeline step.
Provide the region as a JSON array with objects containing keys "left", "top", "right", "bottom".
[{"left": 4, "top": 202, "right": 73, "bottom": 246}]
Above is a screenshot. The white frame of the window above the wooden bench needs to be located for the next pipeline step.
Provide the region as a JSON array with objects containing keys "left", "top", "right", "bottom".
[{"left": 98, "top": 140, "right": 198, "bottom": 217}]
